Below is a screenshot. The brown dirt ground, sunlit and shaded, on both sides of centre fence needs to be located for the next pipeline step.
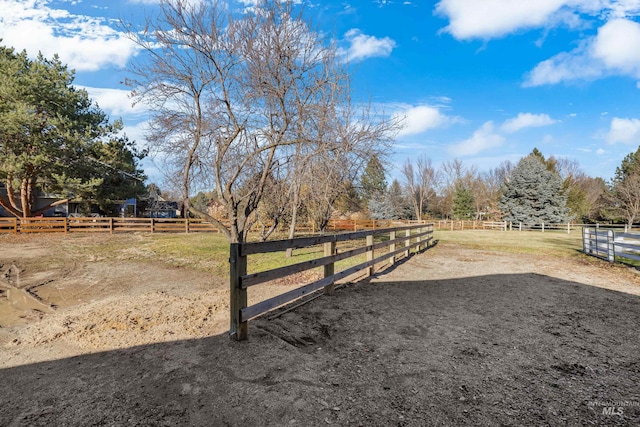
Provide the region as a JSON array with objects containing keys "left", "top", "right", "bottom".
[{"left": 0, "top": 237, "right": 640, "bottom": 426}]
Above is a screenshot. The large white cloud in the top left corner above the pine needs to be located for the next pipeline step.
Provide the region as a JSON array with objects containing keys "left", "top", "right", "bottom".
[{"left": 0, "top": 0, "right": 136, "bottom": 71}]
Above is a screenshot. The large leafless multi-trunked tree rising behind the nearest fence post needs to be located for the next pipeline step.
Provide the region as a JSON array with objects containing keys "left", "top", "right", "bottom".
[{"left": 127, "top": 0, "right": 396, "bottom": 242}]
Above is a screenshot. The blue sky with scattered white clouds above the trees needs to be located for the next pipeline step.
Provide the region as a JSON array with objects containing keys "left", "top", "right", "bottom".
[{"left": 0, "top": 0, "right": 640, "bottom": 186}]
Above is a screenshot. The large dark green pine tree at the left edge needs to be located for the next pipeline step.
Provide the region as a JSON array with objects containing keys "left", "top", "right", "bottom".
[{"left": 0, "top": 47, "right": 144, "bottom": 217}]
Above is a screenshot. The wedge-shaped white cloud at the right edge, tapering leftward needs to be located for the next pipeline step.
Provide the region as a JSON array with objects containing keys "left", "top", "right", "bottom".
[{"left": 524, "top": 19, "right": 640, "bottom": 86}]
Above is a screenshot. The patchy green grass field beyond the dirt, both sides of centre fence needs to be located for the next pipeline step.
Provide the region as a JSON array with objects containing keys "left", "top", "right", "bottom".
[{"left": 10, "top": 230, "right": 582, "bottom": 286}]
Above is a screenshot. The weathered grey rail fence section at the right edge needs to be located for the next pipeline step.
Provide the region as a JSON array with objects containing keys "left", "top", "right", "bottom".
[{"left": 582, "top": 227, "right": 640, "bottom": 262}]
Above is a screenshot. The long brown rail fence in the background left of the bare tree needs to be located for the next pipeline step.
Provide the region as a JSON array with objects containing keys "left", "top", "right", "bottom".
[{"left": 0, "top": 217, "right": 219, "bottom": 234}]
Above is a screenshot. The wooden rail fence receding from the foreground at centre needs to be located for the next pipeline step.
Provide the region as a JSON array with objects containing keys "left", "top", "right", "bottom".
[{"left": 229, "top": 224, "right": 433, "bottom": 340}]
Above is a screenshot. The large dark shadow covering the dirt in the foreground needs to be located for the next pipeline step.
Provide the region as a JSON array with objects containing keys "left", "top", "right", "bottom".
[{"left": 0, "top": 274, "right": 640, "bottom": 426}]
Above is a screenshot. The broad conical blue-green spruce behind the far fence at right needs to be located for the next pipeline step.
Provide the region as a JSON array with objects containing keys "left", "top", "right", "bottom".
[{"left": 499, "top": 153, "right": 569, "bottom": 224}]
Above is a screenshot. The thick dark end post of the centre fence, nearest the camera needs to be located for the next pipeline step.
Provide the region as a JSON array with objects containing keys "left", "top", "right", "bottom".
[{"left": 229, "top": 243, "right": 248, "bottom": 341}]
